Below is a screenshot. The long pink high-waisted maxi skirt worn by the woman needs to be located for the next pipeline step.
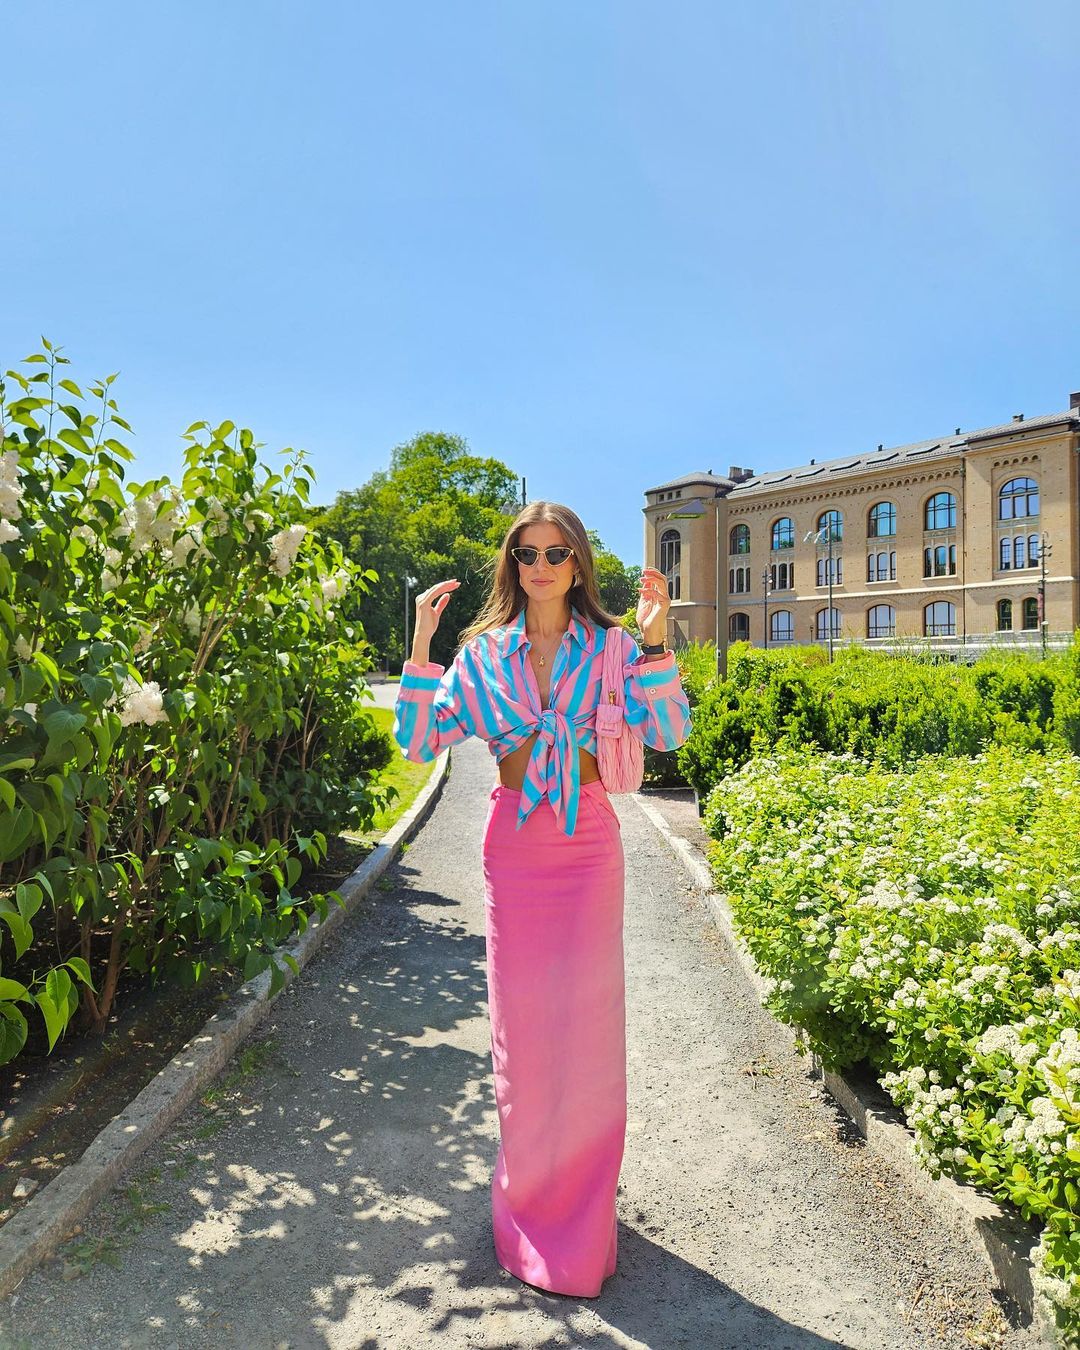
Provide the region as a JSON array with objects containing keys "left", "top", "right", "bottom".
[{"left": 483, "top": 782, "right": 626, "bottom": 1297}]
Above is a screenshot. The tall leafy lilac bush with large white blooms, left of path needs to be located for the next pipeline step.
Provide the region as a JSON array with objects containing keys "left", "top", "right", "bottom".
[{"left": 0, "top": 344, "right": 390, "bottom": 1062}]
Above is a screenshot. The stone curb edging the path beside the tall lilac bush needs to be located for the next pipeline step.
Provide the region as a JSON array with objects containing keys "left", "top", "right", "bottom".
[{"left": 0, "top": 751, "right": 450, "bottom": 1297}]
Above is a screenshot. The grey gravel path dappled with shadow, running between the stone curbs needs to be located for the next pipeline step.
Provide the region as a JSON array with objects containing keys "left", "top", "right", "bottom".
[{"left": 0, "top": 741, "right": 1034, "bottom": 1350}]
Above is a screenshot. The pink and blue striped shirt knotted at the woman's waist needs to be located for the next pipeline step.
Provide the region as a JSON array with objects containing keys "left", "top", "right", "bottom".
[{"left": 394, "top": 608, "right": 690, "bottom": 834}]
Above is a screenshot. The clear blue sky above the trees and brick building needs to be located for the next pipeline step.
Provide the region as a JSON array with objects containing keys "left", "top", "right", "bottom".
[{"left": 0, "top": 0, "right": 1080, "bottom": 562}]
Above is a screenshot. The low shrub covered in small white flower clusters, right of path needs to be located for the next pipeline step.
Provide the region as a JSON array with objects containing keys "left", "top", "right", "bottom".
[{"left": 705, "top": 747, "right": 1080, "bottom": 1335}]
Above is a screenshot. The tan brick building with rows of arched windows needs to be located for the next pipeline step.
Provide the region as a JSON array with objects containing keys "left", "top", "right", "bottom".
[{"left": 644, "top": 394, "right": 1080, "bottom": 657}]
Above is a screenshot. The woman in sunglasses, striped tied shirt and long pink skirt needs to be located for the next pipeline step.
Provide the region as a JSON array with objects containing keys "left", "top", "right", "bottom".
[{"left": 394, "top": 501, "right": 690, "bottom": 1297}]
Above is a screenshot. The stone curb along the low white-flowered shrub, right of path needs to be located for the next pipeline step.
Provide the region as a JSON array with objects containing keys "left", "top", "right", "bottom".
[{"left": 635, "top": 795, "right": 1060, "bottom": 1350}]
